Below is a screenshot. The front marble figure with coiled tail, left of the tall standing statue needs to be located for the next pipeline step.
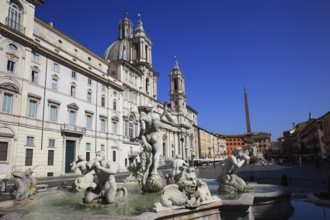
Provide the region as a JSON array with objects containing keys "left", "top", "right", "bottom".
[{"left": 83, "top": 151, "right": 127, "bottom": 204}]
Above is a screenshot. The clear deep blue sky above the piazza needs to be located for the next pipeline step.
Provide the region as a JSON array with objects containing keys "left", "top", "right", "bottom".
[{"left": 36, "top": 0, "right": 330, "bottom": 140}]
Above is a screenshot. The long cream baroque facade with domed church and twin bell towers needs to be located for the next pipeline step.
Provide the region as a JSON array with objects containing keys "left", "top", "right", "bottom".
[{"left": 0, "top": 0, "right": 199, "bottom": 179}]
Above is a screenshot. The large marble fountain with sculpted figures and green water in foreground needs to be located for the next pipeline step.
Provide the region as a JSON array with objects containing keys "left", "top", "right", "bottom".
[{"left": 0, "top": 106, "right": 293, "bottom": 220}]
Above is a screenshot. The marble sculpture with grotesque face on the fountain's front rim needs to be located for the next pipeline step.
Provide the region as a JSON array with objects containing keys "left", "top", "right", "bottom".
[{"left": 154, "top": 166, "right": 220, "bottom": 212}]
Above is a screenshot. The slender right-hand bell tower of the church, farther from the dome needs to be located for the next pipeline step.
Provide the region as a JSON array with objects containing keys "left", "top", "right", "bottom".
[{"left": 170, "top": 57, "right": 186, "bottom": 112}]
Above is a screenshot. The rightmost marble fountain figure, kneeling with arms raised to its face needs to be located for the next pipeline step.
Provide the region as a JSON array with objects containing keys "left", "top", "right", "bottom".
[{"left": 218, "top": 147, "right": 250, "bottom": 193}]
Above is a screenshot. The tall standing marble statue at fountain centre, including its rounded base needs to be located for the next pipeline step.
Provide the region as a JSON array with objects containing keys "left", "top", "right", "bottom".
[{"left": 131, "top": 105, "right": 166, "bottom": 192}]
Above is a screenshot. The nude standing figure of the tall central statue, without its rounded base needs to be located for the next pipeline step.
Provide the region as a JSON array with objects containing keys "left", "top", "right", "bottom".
[{"left": 135, "top": 104, "right": 162, "bottom": 175}]
